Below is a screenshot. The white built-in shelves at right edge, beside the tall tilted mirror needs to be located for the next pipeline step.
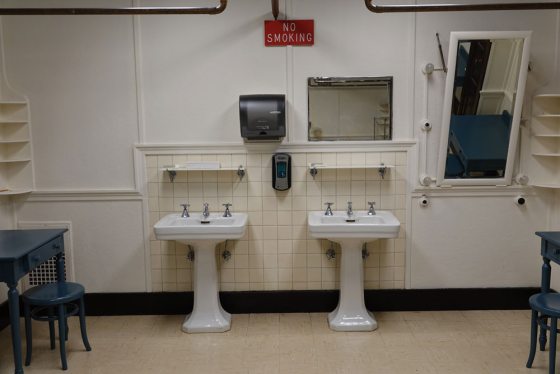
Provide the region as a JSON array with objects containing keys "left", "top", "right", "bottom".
[{"left": 529, "top": 94, "right": 560, "bottom": 188}]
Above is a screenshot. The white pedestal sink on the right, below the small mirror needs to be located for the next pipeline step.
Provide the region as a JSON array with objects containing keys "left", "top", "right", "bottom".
[{"left": 307, "top": 211, "right": 400, "bottom": 331}]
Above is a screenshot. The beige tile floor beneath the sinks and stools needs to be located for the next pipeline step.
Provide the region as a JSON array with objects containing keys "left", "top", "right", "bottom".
[{"left": 0, "top": 311, "right": 548, "bottom": 374}]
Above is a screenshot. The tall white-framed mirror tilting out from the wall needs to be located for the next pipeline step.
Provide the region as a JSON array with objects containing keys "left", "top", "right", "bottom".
[{"left": 437, "top": 31, "right": 531, "bottom": 185}]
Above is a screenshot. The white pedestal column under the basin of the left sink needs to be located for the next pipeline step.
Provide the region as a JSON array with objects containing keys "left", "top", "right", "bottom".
[{"left": 182, "top": 240, "right": 231, "bottom": 333}]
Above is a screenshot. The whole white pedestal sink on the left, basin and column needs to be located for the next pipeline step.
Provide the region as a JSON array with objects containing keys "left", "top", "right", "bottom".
[{"left": 154, "top": 213, "right": 247, "bottom": 333}]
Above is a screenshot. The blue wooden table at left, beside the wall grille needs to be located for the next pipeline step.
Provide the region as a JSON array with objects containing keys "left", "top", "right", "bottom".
[{"left": 0, "top": 229, "right": 68, "bottom": 374}]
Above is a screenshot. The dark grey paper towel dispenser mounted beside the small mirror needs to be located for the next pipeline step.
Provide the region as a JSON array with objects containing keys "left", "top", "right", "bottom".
[{"left": 239, "top": 95, "right": 286, "bottom": 140}]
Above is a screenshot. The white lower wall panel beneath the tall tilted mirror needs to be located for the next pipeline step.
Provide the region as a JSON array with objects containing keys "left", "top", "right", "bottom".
[{"left": 410, "top": 196, "right": 546, "bottom": 288}]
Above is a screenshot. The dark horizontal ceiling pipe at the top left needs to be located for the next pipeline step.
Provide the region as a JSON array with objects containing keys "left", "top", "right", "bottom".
[{"left": 0, "top": 0, "right": 227, "bottom": 16}]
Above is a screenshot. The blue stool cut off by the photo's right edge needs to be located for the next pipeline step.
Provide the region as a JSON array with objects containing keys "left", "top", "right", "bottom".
[{"left": 527, "top": 292, "right": 560, "bottom": 374}]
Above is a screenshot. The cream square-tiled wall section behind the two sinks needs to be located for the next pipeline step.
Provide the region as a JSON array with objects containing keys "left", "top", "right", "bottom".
[{"left": 146, "top": 152, "right": 407, "bottom": 292}]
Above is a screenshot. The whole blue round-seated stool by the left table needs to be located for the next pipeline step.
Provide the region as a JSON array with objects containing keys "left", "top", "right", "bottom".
[{"left": 22, "top": 282, "right": 91, "bottom": 370}]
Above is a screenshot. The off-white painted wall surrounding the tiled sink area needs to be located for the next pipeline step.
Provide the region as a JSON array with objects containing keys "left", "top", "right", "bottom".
[{"left": 0, "top": 0, "right": 560, "bottom": 292}]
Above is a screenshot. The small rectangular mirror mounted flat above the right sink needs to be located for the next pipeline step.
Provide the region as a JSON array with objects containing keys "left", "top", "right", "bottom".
[{"left": 307, "top": 77, "right": 393, "bottom": 141}]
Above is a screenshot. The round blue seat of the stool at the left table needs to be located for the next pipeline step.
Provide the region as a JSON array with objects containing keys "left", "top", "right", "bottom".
[{"left": 22, "top": 282, "right": 85, "bottom": 306}]
